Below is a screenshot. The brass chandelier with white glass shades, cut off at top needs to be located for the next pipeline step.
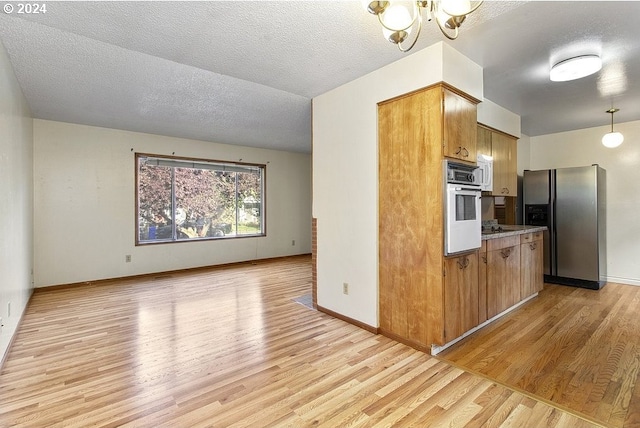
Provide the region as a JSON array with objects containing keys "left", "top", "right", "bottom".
[{"left": 363, "top": 0, "right": 483, "bottom": 52}]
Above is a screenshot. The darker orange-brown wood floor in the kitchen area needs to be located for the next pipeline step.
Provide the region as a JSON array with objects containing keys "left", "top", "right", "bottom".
[{"left": 439, "top": 283, "right": 640, "bottom": 427}]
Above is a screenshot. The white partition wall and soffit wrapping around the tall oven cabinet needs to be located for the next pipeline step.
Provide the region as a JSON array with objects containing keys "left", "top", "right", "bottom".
[{"left": 313, "top": 43, "right": 483, "bottom": 327}]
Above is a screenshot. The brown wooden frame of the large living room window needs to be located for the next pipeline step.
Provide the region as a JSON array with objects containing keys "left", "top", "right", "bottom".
[{"left": 134, "top": 152, "right": 267, "bottom": 246}]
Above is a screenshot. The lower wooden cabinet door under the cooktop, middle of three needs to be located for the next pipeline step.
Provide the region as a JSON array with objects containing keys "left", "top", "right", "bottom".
[{"left": 487, "top": 244, "right": 521, "bottom": 318}]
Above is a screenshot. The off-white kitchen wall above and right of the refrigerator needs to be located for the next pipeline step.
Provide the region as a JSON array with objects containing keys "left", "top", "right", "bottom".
[{"left": 530, "top": 121, "right": 640, "bottom": 285}]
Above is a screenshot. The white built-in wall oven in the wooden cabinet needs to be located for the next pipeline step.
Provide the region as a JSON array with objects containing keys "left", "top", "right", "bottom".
[{"left": 443, "top": 160, "right": 482, "bottom": 256}]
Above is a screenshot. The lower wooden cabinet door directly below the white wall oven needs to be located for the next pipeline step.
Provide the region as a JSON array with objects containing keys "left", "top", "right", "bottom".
[{"left": 444, "top": 252, "right": 479, "bottom": 342}]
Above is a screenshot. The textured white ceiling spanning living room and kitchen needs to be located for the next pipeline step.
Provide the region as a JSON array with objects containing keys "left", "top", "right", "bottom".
[{"left": 0, "top": 1, "right": 640, "bottom": 152}]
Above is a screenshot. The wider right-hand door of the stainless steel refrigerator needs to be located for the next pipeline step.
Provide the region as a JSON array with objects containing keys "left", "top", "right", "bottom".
[{"left": 555, "top": 166, "right": 600, "bottom": 281}]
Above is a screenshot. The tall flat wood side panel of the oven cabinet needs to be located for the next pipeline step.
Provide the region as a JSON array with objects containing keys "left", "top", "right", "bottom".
[{"left": 378, "top": 87, "right": 443, "bottom": 346}]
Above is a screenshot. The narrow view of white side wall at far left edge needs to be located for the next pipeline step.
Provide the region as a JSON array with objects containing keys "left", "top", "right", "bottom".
[{"left": 0, "top": 43, "right": 33, "bottom": 360}]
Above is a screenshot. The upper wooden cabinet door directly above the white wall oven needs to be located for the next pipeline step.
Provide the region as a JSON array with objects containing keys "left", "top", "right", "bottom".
[{"left": 443, "top": 89, "right": 478, "bottom": 162}]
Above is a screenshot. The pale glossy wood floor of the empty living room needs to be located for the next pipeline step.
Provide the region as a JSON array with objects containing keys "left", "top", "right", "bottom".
[{"left": 0, "top": 257, "right": 597, "bottom": 428}]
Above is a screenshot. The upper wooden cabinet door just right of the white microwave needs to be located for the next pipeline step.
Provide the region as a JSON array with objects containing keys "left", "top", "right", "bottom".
[{"left": 491, "top": 132, "right": 518, "bottom": 196}]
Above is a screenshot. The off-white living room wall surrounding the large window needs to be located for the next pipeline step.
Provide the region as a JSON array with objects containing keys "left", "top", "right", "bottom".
[{"left": 33, "top": 120, "right": 311, "bottom": 287}]
